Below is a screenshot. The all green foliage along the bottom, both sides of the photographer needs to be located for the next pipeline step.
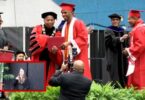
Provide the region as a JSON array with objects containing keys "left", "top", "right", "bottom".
[{"left": 10, "top": 82, "right": 145, "bottom": 100}]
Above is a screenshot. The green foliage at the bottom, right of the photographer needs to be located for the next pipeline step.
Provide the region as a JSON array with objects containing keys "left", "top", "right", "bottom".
[{"left": 86, "top": 82, "right": 145, "bottom": 100}]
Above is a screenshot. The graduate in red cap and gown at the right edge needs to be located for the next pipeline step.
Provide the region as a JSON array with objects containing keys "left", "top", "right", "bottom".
[{"left": 123, "top": 10, "right": 145, "bottom": 89}]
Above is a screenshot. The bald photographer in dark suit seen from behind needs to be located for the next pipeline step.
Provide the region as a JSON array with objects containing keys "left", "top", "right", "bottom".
[{"left": 49, "top": 60, "right": 92, "bottom": 100}]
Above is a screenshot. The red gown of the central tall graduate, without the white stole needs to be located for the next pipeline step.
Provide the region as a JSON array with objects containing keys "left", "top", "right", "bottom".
[{"left": 58, "top": 19, "right": 92, "bottom": 79}]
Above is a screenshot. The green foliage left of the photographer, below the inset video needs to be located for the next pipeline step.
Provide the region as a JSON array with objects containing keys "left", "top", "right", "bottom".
[{"left": 10, "top": 87, "right": 59, "bottom": 100}]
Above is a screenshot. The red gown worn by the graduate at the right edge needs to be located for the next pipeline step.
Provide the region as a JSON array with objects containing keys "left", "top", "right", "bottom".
[{"left": 128, "top": 19, "right": 145, "bottom": 89}]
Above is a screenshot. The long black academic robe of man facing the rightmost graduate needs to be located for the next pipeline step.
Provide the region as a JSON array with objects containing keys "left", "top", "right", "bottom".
[{"left": 105, "top": 26, "right": 128, "bottom": 87}]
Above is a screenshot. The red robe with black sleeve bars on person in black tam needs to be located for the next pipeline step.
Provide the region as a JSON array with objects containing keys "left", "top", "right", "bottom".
[{"left": 29, "top": 25, "right": 62, "bottom": 83}]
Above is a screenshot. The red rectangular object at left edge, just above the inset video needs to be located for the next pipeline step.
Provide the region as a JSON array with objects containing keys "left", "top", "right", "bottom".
[{"left": 0, "top": 50, "right": 14, "bottom": 62}]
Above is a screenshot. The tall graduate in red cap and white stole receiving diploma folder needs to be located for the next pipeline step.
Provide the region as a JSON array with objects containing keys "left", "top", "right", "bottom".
[{"left": 57, "top": 3, "right": 91, "bottom": 79}]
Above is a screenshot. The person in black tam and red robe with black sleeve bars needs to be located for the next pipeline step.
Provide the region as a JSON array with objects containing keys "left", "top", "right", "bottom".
[{"left": 29, "top": 12, "right": 62, "bottom": 82}]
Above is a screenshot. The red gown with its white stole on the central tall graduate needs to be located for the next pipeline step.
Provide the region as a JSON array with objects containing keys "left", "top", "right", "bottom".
[{"left": 57, "top": 18, "right": 92, "bottom": 79}]
